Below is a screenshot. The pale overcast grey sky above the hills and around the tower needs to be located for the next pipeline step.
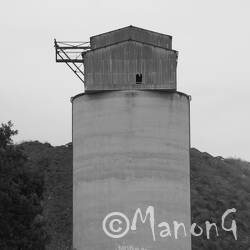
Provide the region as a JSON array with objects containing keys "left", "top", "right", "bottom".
[{"left": 0, "top": 0, "right": 250, "bottom": 160}]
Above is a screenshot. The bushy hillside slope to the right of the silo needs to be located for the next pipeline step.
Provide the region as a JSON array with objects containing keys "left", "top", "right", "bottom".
[{"left": 190, "top": 149, "right": 250, "bottom": 250}]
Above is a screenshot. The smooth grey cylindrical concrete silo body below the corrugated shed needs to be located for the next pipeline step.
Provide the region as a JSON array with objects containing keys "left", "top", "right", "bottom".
[{"left": 73, "top": 90, "right": 191, "bottom": 250}]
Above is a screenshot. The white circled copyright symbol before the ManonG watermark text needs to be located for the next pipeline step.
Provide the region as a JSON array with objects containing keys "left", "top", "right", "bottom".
[{"left": 102, "top": 212, "right": 129, "bottom": 239}]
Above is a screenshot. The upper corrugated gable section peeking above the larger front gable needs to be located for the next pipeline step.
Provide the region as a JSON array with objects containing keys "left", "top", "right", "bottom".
[{"left": 90, "top": 26, "right": 172, "bottom": 49}]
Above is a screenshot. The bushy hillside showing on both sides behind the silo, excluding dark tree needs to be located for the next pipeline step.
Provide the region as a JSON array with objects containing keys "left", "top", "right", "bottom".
[{"left": 20, "top": 142, "right": 250, "bottom": 250}]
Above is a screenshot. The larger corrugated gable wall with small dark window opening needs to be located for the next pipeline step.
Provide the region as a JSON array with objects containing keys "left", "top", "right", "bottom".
[{"left": 84, "top": 41, "right": 177, "bottom": 91}]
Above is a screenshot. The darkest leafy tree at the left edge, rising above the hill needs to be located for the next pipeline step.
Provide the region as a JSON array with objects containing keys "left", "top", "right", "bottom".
[{"left": 0, "top": 122, "right": 47, "bottom": 250}]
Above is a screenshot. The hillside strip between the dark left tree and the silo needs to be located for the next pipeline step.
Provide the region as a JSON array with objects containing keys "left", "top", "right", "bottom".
[{"left": 18, "top": 141, "right": 73, "bottom": 250}]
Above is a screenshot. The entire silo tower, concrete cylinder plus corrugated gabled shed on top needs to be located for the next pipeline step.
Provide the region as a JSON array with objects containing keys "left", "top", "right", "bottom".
[{"left": 56, "top": 26, "right": 191, "bottom": 250}]
